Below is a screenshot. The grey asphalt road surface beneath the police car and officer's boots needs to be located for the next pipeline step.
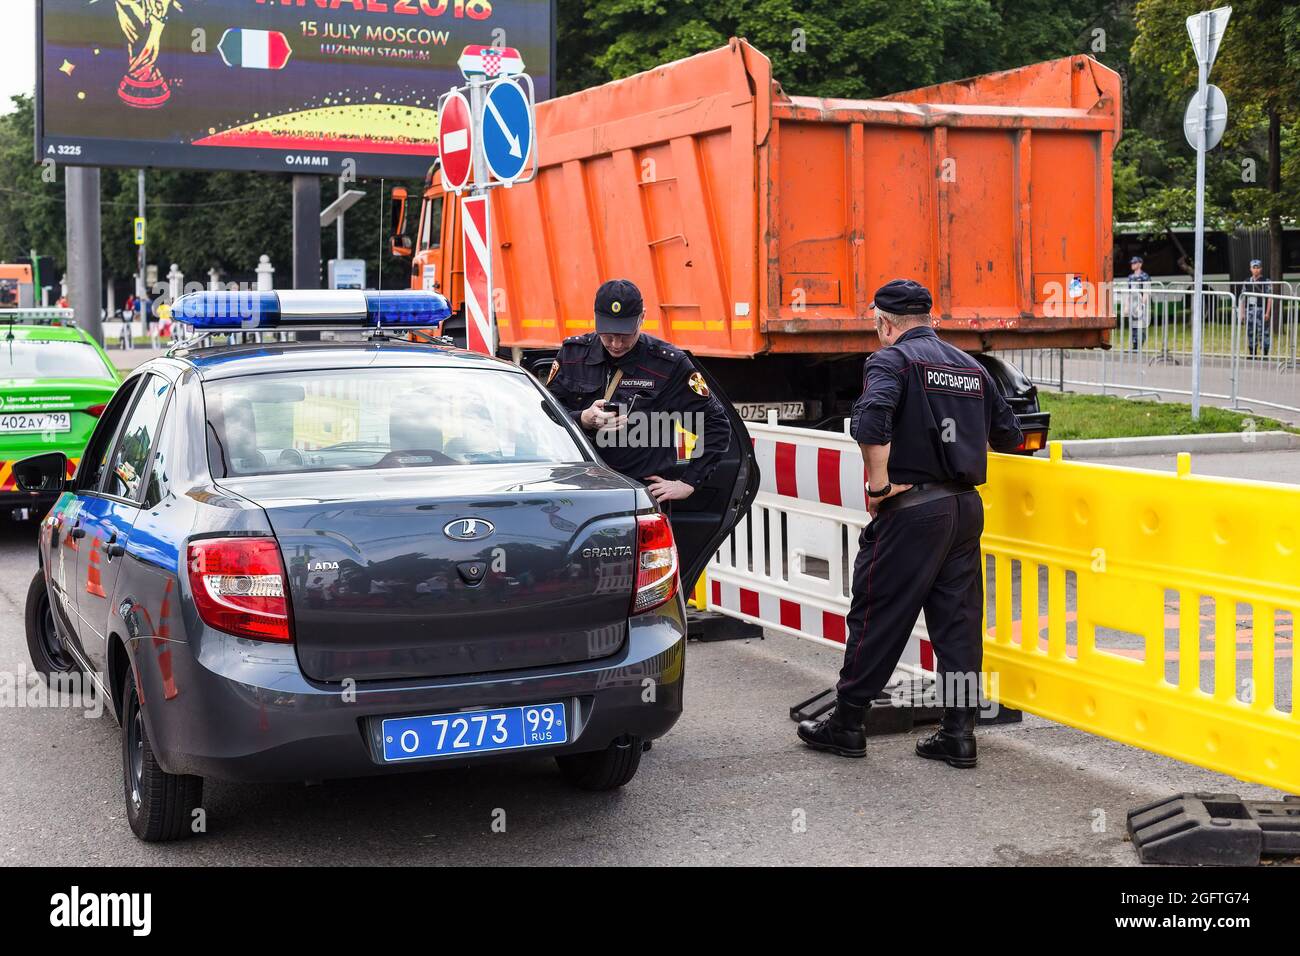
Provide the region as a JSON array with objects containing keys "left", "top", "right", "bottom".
[{"left": 0, "top": 525, "right": 1277, "bottom": 865}]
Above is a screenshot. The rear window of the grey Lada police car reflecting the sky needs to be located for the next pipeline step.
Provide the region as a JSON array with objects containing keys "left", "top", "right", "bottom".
[{"left": 204, "top": 368, "right": 584, "bottom": 477}]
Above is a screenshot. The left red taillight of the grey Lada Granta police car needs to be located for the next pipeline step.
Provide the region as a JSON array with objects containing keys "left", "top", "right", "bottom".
[{"left": 190, "top": 537, "right": 294, "bottom": 641}]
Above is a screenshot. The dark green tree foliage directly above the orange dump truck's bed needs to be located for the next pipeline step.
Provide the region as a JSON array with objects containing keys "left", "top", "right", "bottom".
[{"left": 559, "top": 0, "right": 1108, "bottom": 98}]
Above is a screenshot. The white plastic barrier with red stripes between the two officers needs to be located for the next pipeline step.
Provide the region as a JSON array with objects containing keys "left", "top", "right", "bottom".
[{"left": 706, "top": 423, "right": 935, "bottom": 678}]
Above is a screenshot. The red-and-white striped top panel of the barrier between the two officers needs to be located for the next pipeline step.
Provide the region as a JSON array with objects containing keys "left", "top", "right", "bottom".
[{"left": 754, "top": 433, "right": 867, "bottom": 515}]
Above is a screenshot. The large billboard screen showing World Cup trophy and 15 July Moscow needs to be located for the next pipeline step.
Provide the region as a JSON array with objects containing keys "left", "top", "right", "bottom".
[{"left": 36, "top": 0, "right": 554, "bottom": 178}]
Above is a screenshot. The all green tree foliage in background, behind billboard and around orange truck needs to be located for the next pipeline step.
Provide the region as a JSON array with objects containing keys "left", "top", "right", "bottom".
[{"left": 0, "top": 0, "right": 1300, "bottom": 286}]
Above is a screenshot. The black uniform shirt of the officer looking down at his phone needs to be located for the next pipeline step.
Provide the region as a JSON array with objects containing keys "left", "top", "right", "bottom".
[{"left": 546, "top": 332, "right": 731, "bottom": 488}]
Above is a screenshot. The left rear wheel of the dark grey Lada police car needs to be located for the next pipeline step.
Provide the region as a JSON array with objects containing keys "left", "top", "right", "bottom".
[{"left": 122, "top": 670, "right": 203, "bottom": 843}]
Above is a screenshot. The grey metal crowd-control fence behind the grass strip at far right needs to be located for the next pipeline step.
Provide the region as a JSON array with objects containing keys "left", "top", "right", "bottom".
[{"left": 1001, "top": 282, "right": 1300, "bottom": 412}]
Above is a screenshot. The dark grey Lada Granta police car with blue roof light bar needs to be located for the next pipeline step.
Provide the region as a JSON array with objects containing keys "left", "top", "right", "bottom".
[{"left": 16, "top": 293, "right": 754, "bottom": 840}]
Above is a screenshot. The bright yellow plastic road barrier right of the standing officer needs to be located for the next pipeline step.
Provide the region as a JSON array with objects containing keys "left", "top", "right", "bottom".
[{"left": 980, "top": 442, "right": 1300, "bottom": 792}]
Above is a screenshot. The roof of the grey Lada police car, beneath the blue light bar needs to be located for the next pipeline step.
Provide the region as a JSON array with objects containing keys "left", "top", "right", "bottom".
[{"left": 168, "top": 339, "right": 523, "bottom": 380}]
